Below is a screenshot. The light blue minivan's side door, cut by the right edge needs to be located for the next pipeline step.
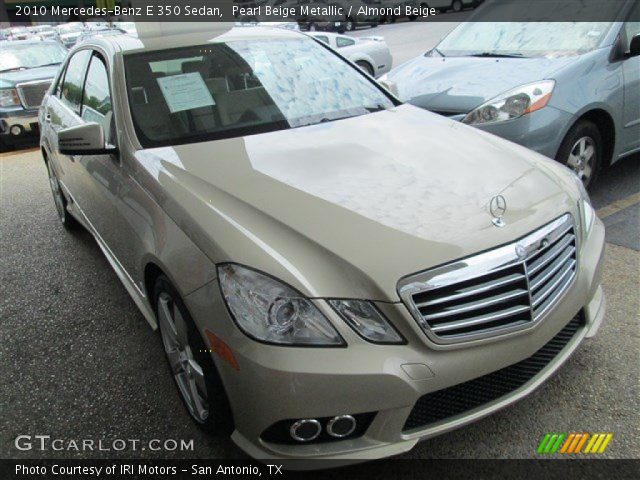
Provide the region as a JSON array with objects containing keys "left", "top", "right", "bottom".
[{"left": 620, "top": 13, "right": 640, "bottom": 154}]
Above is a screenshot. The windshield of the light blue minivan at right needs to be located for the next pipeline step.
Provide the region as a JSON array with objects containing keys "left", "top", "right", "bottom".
[{"left": 435, "top": 22, "right": 612, "bottom": 57}]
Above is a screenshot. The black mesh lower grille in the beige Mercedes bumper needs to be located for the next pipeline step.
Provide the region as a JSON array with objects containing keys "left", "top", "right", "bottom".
[{"left": 403, "top": 313, "right": 584, "bottom": 431}]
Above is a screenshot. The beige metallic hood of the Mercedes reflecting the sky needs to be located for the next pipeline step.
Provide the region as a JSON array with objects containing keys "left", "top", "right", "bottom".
[{"left": 135, "top": 105, "right": 576, "bottom": 301}]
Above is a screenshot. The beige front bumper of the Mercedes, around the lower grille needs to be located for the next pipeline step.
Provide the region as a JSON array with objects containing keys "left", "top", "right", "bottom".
[{"left": 186, "top": 219, "right": 604, "bottom": 466}]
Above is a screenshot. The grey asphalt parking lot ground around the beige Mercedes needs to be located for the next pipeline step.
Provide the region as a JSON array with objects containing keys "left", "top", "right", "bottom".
[{"left": 0, "top": 19, "right": 640, "bottom": 458}]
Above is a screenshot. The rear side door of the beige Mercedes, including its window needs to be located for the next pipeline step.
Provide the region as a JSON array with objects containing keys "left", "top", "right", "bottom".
[{"left": 45, "top": 50, "right": 91, "bottom": 198}]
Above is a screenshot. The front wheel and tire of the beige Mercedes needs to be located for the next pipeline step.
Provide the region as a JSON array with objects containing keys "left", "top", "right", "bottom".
[{"left": 153, "top": 275, "right": 233, "bottom": 435}]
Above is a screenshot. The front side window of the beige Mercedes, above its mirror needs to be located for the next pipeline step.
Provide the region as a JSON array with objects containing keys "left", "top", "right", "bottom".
[{"left": 81, "top": 55, "right": 113, "bottom": 142}]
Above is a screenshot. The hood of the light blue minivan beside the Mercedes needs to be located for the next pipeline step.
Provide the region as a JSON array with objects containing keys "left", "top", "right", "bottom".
[{"left": 389, "top": 56, "right": 576, "bottom": 114}]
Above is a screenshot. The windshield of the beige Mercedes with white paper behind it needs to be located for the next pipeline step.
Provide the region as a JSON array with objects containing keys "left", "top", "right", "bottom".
[{"left": 125, "top": 37, "right": 394, "bottom": 147}]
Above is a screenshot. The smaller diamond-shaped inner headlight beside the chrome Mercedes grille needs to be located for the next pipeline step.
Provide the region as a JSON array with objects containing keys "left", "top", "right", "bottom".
[{"left": 329, "top": 300, "right": 404, "bottom": 343}]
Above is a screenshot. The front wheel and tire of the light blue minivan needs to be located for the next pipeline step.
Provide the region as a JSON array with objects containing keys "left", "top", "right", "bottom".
[{"left": 556, "top": 120, "right": 603, "bottom": 189}]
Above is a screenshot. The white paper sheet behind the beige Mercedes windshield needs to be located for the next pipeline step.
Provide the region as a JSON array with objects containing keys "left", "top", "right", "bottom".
[{"left": 158, "top": 72, "right": 216, "bottom": 113}]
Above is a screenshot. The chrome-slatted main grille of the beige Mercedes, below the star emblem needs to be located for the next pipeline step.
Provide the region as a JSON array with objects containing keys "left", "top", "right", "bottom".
[{"left": 399, "top": 214, "right": 577, "bottom": 343}]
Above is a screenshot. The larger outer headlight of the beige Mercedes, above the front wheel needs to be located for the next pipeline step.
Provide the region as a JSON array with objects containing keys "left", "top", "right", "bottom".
[{"left": 218, "top": 264, "right": 345, "bottom": 346}]
